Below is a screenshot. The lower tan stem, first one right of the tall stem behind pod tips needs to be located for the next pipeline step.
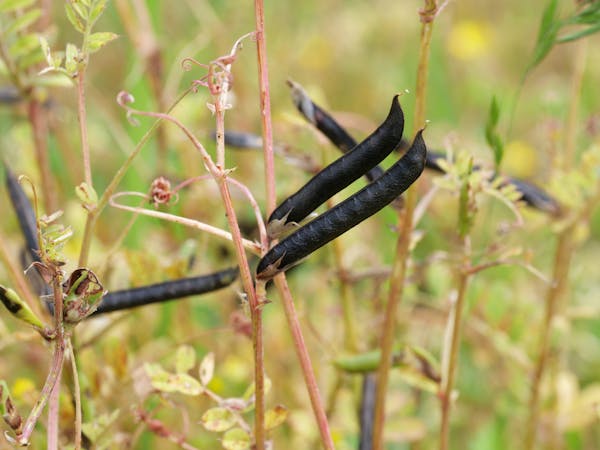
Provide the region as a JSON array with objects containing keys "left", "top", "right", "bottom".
[{"left": 440, "top": 237, "right": 471, "bottom": 450}]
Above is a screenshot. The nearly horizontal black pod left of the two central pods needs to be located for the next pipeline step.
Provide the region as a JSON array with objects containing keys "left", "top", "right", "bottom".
[{"left": 92, "top": 267, "right": 238, "bottom": 316}]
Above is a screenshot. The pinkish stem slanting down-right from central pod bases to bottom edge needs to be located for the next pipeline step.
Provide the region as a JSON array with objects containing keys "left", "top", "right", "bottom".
[{"left": 275, "top": 274, "right": 335, "bottom": 450}]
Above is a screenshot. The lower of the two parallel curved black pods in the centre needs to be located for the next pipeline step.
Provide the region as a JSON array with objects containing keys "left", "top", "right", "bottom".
[{"left": 256, "top": 130, "right": 427, "bottom": 279}]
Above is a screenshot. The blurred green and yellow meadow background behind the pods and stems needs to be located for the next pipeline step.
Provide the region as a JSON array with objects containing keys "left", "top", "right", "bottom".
[{"left": 0, "top": 0, "right": 600, "bottom": 450}]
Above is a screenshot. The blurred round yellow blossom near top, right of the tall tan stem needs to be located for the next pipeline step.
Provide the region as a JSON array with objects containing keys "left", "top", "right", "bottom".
[{"left": 447, "top": 20, "right": 492, "bottom": 61}]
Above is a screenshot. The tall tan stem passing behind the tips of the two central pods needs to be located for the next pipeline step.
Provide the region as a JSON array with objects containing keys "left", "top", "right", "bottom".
[{"left": 373, "top": 0, "right": 437, "bottom": 450}]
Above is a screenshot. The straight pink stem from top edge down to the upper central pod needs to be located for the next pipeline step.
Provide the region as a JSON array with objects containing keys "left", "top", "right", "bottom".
[{"left": 254, "top": 0, "right": 277, "bottom": 215}]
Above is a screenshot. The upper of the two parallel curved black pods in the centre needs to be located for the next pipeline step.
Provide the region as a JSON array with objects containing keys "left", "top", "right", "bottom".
[{"left": 267, "top": 95, "right": 404, "bottom": 236}]
